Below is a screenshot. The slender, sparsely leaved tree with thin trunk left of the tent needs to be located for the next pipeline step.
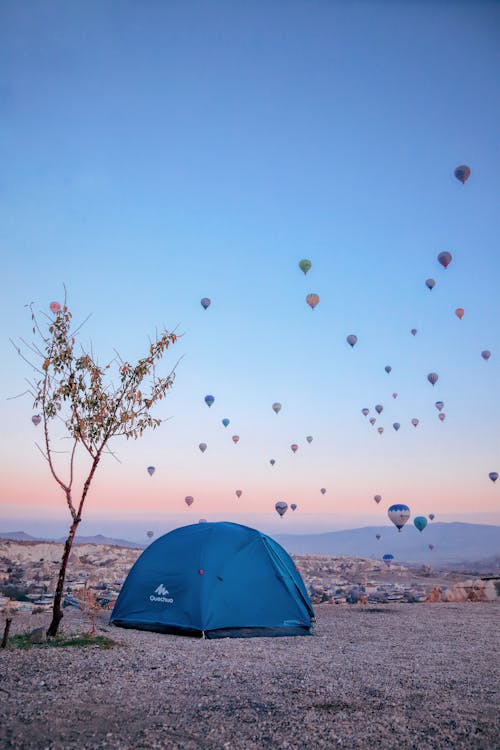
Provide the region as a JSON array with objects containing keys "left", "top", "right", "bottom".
[{"left": 12, "top": 303, "right": 177, "bottom": 636}]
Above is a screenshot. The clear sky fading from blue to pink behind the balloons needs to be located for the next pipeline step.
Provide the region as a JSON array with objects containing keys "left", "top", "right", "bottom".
[{"left": 0, "top": 0, "right": 500, "bottom": 540}]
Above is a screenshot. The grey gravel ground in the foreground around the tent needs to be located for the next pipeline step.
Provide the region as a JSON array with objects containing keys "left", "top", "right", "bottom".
[{"left": 0, "top": 603, "right": 500, "bottom": 750}]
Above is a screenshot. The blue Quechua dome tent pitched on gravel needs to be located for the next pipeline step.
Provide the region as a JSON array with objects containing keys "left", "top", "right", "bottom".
[{"left": 111, "top": 522, "right": 314, "bottom": 638}]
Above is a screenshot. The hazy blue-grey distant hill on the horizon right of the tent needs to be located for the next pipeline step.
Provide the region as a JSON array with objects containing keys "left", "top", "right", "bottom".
[{"left": 274, "top": 523, "right": 500, "bottom": 563}]
